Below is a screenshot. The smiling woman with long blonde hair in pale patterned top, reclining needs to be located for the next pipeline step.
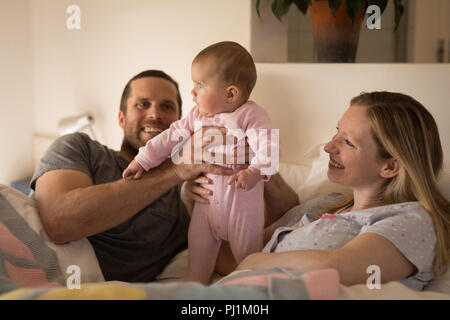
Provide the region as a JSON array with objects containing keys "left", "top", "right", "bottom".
[{"left": 186, "top": 92, "right": 450, "bottom": 290}]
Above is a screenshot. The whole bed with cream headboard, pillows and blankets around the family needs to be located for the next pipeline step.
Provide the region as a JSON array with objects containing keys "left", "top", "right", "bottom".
[{"left": 0, "top": 64, "right": 450, "bottom": 300}]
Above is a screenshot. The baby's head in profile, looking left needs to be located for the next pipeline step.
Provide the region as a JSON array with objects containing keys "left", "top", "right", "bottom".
[{"left": 191, "top": 41, "right": 256, "bottom": 116}]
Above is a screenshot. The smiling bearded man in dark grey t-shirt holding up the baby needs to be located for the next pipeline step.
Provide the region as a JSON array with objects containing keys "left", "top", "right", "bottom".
[{"left": 31, "top": 70, "right": 298, "bottom": 282}]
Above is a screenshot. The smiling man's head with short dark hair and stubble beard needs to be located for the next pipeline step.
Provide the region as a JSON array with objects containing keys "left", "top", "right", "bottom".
[{"left": 119, "top": 77, "right": 179, "bottom": 152}]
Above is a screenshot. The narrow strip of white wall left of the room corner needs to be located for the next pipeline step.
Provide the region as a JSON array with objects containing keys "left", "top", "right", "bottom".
[{"left": 0, "top": 0, "right": 34, "bottom": 184}]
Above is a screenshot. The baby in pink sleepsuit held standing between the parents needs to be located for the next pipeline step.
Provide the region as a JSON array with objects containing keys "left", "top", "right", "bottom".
[{"left": 123, "top": 41, "right": 279, "bottom": 284}]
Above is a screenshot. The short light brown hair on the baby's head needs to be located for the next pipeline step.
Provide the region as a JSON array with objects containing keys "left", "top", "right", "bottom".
[{"left": 194, "top": 41, "right": 257, "bottom": 100}]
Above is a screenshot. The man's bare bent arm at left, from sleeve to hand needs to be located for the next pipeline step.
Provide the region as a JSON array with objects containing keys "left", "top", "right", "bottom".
[{"left": 35, "top": 159, "right": 230, "bottom": 243}]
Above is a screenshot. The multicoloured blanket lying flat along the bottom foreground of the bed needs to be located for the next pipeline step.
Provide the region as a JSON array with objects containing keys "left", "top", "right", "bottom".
[{"left": 0, "top": 268, "right": 339, "bottom": 300}]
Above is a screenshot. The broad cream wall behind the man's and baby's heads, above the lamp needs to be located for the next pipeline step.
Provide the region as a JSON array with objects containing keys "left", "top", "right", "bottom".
[{"left": 31, "top": 0, "right": 251, "bottom": 148}]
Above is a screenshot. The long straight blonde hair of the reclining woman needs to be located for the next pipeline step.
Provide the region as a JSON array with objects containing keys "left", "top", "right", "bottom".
[{"left": 328, "top": 92, "right": 450, "bottom": 276}]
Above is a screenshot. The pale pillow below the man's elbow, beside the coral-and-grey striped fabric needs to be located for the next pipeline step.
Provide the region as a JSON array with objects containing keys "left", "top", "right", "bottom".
[{"left": 0, "top": 184, "right": 105, "bottom": 283}]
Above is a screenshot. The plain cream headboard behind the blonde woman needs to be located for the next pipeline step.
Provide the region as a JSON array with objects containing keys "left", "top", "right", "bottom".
[{"left": 251, "top": 63, "right": 450, "bottom": 165}]
